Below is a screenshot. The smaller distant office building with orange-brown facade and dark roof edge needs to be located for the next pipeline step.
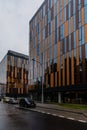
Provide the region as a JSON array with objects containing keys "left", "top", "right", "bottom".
[{"left": 0, "top": 50, "right": 29, "bottom": 97}]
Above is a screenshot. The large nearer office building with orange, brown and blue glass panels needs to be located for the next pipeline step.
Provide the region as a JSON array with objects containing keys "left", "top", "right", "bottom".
[{"left": 29, "top": 0, "right": 87, "bottom": 103}]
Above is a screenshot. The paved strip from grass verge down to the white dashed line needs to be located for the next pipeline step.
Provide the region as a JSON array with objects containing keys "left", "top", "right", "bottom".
[{"left": 15, "top": 103, "right": 87, "bottom": 123}]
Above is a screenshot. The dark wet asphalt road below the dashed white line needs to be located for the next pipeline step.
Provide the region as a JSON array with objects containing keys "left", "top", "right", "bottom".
[{"left": 0, "top": 103, "right": 87, "bottom": 130}]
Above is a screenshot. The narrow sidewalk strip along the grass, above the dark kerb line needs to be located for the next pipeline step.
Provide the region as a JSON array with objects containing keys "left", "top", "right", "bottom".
[{"left": 37, "top": 103, "right": 87, "bottom": 118}]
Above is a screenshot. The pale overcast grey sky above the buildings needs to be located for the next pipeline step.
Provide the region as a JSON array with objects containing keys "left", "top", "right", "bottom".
[{"left": 0, "top": 0, "right": 44, "bottom": 61}]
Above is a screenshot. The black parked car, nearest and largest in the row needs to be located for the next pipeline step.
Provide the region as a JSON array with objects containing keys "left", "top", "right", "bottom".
[{"left": 19, "top": 98, "right": 36, "bottom": 108}]
